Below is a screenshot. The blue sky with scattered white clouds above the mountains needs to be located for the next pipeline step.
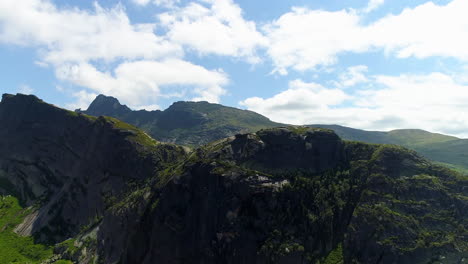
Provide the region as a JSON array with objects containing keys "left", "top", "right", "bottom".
[{"left": 0, "top": 0, "right": 468, "bottom": 138}]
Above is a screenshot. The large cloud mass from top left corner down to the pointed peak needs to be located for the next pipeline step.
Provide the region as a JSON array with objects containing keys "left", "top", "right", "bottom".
[{"left": 0, "top": 0, "right": 230, "bottom": 108}]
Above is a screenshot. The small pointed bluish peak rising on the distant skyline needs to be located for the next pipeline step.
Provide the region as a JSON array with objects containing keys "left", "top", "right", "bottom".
[{"left": 86, "top": 94, "right": 132, "bottom": 116}]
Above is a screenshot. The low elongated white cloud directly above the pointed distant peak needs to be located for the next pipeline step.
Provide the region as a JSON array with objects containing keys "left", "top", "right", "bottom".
[{"left": 56, "top": 59, "right": 229, "bottom": 109}]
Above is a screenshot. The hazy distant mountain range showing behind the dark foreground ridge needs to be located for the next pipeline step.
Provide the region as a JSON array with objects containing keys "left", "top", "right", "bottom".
[{"left": 77, "top": 95, "right": 468, "bottom": 172}]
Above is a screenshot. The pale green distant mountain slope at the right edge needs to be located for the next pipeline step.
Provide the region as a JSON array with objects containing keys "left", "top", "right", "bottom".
[{"left": 310, "top": 124, "right": 468, "bottom": 173}]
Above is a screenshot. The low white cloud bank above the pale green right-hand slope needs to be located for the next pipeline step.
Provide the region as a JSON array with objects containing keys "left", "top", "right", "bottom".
[{"left": 240, "top": 72, "right": 468, "bottom": 137}]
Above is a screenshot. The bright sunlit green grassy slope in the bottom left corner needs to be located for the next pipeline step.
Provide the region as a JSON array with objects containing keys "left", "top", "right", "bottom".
[{"left": 0, "top": 196, "right": 52, "bottom": 264}]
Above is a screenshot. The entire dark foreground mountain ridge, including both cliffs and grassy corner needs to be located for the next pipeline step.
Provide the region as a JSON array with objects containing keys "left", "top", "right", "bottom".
[{"left": 0, "top": 95, "right": 468, "bottom": 264}]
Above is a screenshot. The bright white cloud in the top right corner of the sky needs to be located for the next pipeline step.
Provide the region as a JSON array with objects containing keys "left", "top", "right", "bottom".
[{"left": 369, "top": 0, "right": 468, "bottom": 61}]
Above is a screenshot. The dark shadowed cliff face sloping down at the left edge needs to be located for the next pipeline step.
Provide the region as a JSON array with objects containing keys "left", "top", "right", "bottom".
[{"left": 0, "top": 95, "right": 183, "bottom": 242}]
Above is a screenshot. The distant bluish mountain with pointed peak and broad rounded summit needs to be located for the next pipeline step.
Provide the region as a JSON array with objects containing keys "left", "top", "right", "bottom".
[{"left": 78, "top": 95, "right": 281, "bottom": 146}]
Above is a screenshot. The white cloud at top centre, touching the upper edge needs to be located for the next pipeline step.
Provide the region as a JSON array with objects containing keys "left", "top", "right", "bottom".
[{"left": 158, "top": 0, "right": 267, "bottom": 63}]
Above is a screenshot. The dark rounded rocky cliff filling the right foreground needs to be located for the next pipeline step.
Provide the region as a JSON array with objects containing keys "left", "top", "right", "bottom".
[{"left": 99, "top": 128, "right": 468, "bottom": 263}]
